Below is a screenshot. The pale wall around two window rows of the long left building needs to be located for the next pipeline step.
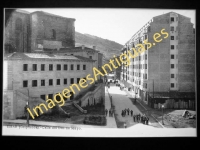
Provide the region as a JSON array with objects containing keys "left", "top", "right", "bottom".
[{"left": 4, "top": 56, "right": 92, "bottom": 102}]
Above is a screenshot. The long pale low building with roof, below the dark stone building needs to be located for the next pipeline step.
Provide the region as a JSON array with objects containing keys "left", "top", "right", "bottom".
[{"left": 3, "top": 53, "right": 97, "bottom": 118}]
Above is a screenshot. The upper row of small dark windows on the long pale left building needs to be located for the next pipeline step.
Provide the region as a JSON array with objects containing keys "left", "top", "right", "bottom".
[{"left": 23, "top": 64, "right": 86, "bottom": 71}]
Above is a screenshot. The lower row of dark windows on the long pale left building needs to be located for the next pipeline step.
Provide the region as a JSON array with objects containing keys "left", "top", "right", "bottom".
[{"left": 23, "top": 78, "right": 83, "bottom": 87}]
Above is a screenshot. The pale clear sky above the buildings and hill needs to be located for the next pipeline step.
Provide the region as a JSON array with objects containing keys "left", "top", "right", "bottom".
[{"left": 20, "top": 8, "right": 196, "bottom": 45}]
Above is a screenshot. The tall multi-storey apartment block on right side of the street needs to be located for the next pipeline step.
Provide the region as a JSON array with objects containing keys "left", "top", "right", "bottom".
[{"left": 121, "top": 12, "right": 195, "bottom": 107}]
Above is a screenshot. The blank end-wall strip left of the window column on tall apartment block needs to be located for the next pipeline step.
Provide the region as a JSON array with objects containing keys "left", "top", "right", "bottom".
[{"left": 147, "top": 14, "right": 170, "bottom": 92}]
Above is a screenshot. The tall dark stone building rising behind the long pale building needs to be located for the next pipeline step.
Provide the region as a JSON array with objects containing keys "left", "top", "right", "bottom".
[{"left": 4, "top": 10, "right": 75, "bottom": 53}]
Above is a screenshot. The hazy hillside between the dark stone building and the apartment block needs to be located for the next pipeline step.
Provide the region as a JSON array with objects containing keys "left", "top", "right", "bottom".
[{"left": 75, "top": 32, "right": 123, "bottom": 59}]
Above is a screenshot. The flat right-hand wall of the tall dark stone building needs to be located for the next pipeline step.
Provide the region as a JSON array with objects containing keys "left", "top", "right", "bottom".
[{"left": 31, "top": 11, "right": 75, "bottom": 51}]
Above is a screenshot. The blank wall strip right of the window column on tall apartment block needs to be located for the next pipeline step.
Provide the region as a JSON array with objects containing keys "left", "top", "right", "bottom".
[{"left": 177, "top": 15, "right": 196, "bottom": 92}]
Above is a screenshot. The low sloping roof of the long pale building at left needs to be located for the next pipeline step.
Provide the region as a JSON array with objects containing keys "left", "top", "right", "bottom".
[{"left": 4, "top": 52, "right": 95, "bottom": 61}]
